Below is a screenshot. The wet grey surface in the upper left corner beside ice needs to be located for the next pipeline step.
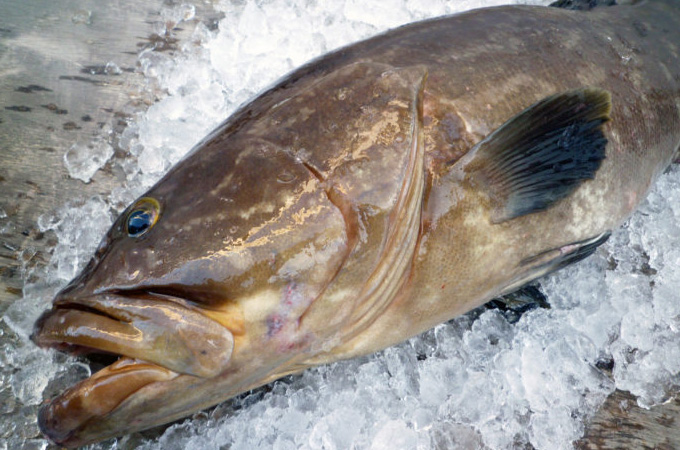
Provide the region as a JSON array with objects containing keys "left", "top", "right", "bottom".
[{"left": 0, "top": 0, "right": 161, "bottom": 311}]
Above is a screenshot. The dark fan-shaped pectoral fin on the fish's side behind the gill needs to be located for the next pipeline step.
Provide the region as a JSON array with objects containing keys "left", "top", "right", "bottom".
[{"left": 460, "top": 88, "right": 611, "bottom": 223}]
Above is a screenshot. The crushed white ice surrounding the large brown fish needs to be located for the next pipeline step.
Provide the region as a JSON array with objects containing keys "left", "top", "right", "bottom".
[{"left": 0, "top": 0, "right": 680, "bottom": 450}]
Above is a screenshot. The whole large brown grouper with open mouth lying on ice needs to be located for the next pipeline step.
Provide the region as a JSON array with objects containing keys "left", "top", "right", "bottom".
[{"left": 32, "top": 0, "right": 680, "bottom": 447}]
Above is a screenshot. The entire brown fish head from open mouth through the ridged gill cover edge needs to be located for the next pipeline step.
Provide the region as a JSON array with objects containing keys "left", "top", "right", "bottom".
[{"left": 33, "top": 63, "right": 426, "bottom": 447}]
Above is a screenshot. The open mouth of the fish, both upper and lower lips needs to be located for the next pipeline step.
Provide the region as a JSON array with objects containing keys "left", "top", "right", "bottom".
[{"left": 31, "top": 293, "right": 234, "bottom": 447}]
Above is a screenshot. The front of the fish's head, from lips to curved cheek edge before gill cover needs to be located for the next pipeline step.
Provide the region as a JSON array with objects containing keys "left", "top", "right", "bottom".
[{"left": 32, "top": 130, "right": 348, "bottom": 447}]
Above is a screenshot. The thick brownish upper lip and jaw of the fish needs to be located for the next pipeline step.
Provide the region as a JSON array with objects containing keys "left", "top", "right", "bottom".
[{"left": 31, "top": 291, "right": 234, "bottom": 378}]
